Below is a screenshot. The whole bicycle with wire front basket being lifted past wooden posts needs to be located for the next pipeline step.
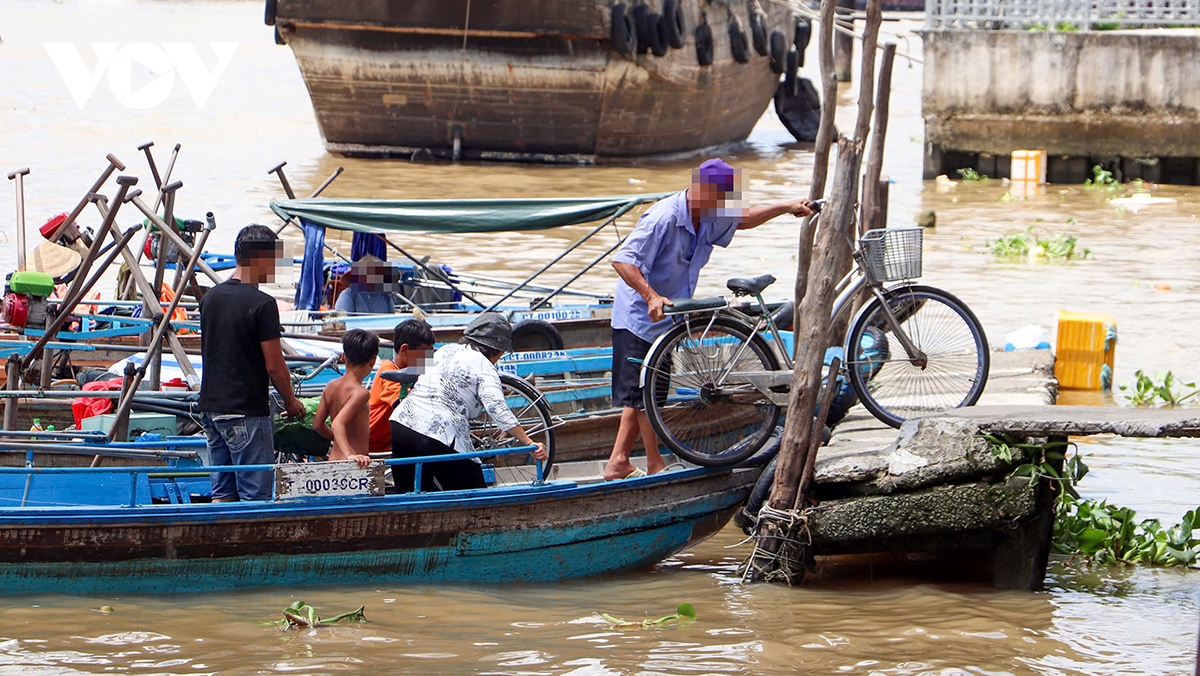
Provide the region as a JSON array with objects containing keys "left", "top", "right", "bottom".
[{"left": 641, "top": 216, "right": 990, "bottom": 466}]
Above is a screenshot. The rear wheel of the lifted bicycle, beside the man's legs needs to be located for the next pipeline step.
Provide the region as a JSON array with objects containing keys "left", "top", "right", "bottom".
[{"left": 642, "top": 317, "right": 779, "bottom": 467}]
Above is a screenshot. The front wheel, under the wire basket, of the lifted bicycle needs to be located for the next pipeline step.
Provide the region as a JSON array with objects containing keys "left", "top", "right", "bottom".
[{"left": 846, "top": 285, "right": 990, "bottom": 427}]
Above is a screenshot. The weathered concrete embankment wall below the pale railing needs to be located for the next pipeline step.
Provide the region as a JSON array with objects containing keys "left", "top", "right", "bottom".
[{"left": 923, "top": 29, "right": 1200, "bottom": 184}]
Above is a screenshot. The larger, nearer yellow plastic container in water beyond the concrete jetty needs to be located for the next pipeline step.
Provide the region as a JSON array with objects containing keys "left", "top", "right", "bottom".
[{"left": 1054, "top": 310, "right": 1117, "bottom": 390}]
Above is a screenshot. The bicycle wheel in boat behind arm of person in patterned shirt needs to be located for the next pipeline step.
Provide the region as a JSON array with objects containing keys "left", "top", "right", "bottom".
[{"left": 470, "top": 373, "right": 554, "bottom": 484}]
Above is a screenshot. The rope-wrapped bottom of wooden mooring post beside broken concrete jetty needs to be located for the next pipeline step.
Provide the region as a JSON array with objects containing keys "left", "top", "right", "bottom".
[{"left": 742, "top": 504, "right": 815, "bottom": 586}]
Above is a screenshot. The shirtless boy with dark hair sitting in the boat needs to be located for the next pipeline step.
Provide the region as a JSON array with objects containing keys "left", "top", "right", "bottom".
[{"left": 312, "top": 329, "right": 379, "bottom": 469}]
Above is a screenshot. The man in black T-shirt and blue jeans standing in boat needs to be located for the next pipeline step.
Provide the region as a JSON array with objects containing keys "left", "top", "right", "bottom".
[{"left": 199, "top": 225, "right": 304, "bottom": 502}]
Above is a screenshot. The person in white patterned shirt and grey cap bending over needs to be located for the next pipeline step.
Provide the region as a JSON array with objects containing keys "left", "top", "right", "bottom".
[{"left": 391, "top": 312, "right": 550, "bottom": 492}]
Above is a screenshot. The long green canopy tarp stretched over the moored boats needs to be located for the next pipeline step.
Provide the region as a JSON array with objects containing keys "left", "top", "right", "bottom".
[{"left": 271, "top": 192, "right": 671, "bottom": 234}]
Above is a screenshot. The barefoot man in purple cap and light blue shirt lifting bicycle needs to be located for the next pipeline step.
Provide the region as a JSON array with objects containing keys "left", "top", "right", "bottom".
[{"left": 604, "top": 158, "right": 812, "bottom": 479}]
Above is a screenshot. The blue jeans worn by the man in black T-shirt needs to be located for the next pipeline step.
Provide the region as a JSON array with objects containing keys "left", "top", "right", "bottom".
[{"left": 200, "top": 413, "right": 275, "bottom": 499}]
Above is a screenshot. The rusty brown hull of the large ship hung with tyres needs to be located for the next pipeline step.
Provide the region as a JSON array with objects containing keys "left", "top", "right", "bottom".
[{"left": 269, "top": 0, "right": 794, "bottom": 161}]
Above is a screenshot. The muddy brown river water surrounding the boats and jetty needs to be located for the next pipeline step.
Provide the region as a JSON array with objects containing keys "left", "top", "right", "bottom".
[{"left": 0, "top": 0, "right": 1200, "bottom": 675}]
